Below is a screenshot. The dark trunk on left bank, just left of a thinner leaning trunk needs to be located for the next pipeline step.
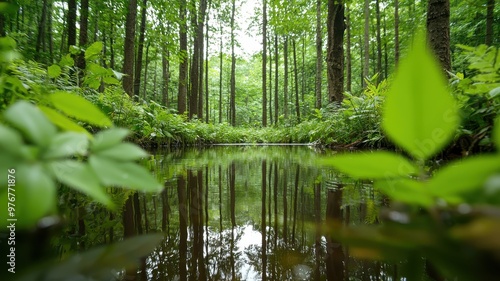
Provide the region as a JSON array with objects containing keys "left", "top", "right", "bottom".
[{"left": 122, "top": 0, "right": 137, "bottom": 98}]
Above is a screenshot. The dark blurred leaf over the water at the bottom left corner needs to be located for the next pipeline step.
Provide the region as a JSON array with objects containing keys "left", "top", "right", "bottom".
[{"left": 19, "top": 233, "right": 164, "bottom": 281}]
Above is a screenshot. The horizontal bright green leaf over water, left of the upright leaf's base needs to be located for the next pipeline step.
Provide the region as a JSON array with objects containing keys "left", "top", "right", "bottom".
[{"left": 322, "top": 151, "right": 419, "bottom": 179}]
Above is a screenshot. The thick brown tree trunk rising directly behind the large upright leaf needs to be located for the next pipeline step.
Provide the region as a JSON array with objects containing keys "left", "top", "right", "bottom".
[{"left": 427, "top": 0, "right": 451, "bottom": 73}]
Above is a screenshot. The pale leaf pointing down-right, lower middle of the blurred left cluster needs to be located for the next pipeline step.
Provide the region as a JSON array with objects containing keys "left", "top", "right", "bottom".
[{"left": 51, "top": 160, "right": 112, "bottom": 207}]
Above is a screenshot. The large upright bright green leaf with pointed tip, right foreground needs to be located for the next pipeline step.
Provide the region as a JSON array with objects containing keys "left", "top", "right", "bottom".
[{"left": 382, "top": 34, "right": 459, "bottom": 160}]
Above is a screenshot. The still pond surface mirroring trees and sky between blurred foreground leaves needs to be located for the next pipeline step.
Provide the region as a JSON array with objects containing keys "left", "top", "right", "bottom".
[{"left": 73, "top": 147, "right": 414, "bottom": 281}]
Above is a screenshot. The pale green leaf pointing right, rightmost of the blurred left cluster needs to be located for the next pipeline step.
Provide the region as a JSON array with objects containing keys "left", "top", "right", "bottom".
[{"left": 89, "top": 155, "right": 163, "bottom": 192}]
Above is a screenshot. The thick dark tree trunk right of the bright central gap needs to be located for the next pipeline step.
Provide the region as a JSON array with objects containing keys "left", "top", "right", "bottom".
[{"left": 327, "top": 0, "right": 345, "bottom": 104}]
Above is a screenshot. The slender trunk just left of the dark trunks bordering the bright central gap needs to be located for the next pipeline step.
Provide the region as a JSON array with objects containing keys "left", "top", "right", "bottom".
[{"left": 177, "top": 0, "right": 188, "bottom": 114}]
